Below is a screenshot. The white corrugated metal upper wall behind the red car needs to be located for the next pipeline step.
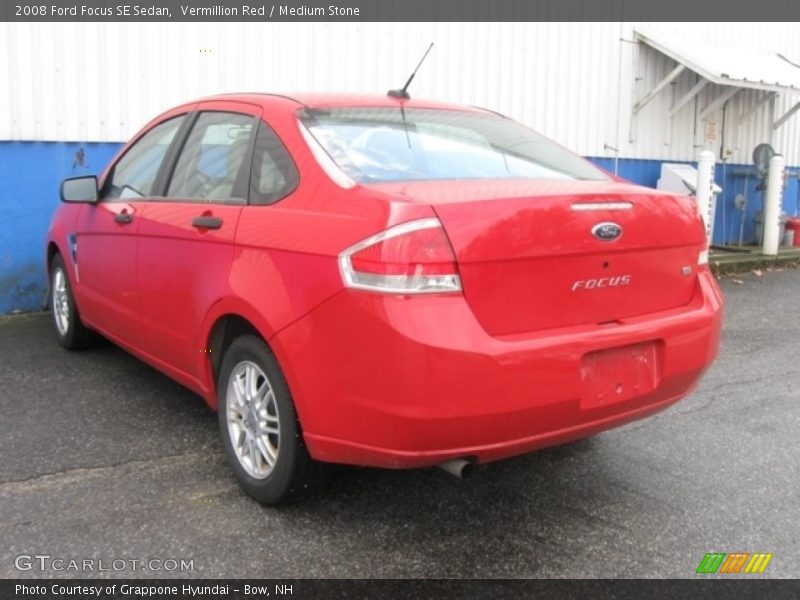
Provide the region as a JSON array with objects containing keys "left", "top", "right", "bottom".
[{"left": 0, "top": 23, "right": 800, "bottom": 165}]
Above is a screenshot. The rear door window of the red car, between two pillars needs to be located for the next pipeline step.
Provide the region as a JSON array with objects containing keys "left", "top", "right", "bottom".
[{"left": 167, "top": 112, "right": 254, "bottom": 202}]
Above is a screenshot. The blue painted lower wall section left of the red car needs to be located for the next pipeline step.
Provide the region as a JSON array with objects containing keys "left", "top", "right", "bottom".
[{"left": 0, "top": 142, "right": 120, "bottom": 314}]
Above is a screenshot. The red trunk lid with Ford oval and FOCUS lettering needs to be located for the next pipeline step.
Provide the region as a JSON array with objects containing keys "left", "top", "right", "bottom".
[{"left": 366, "top": 180, "right": 705, "bottom": 335}]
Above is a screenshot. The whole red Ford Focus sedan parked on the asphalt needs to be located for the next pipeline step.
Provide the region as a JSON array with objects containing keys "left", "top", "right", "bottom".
[{"left": 47, "top": 94, "right": 722, "bottom": 504}]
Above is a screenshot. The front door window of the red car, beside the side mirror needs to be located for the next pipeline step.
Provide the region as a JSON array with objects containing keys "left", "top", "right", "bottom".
[{"left": 102, "top": 115, "right": 185, "bottom": 199}]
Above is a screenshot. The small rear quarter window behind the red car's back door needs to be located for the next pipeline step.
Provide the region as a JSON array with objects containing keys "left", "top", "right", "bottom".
[{"left": 250, "top": 122, "right": 299, "bottom": 204}]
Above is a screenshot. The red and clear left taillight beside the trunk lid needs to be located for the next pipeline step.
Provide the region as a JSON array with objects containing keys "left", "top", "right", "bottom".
[{"left": 339, "top": 219, "right": 461, "bottom": 294}]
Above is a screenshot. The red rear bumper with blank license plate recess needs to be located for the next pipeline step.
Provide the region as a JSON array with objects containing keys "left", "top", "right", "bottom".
[{"left": 273, "top": 271, "right": 722, "bottom": 468}]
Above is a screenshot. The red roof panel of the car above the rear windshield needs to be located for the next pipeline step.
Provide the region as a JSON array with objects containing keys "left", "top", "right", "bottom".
[{"left": 197, "top": 92, "right": 492, "bottom": 112}]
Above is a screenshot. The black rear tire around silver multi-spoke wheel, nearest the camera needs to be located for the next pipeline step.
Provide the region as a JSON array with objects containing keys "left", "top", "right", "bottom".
[{"left": 217, "top": 335, "right": 330, "bottom": 505}]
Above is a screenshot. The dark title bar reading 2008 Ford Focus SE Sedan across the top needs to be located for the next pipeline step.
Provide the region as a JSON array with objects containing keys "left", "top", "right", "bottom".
[{"left": 0, "top": 0, "right": 800, "bottom": 22}]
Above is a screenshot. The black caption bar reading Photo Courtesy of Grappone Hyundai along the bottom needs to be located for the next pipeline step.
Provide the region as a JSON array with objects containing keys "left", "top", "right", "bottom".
[{"left": 0, "top": 575, "right": 800, "bottom": 600}]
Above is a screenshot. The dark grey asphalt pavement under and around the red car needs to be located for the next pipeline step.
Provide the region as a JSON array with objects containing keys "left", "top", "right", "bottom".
[{"left": 0, "top": 271, "right": 800, "bottom": 578}]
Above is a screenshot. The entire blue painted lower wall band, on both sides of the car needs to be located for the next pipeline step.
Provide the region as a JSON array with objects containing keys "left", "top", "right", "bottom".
[{"left": 0, "top": 142, "right": 800, "bottom": 314}]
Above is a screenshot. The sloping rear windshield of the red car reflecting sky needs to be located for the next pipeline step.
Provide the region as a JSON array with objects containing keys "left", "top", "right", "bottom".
[{"left": 300, "top": 106, "right": 608, "bottom": 183}]
